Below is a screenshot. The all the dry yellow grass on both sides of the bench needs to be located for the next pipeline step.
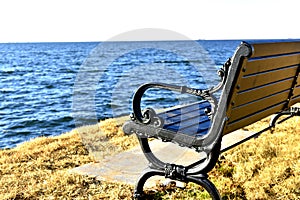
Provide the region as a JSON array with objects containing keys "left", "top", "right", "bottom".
[{"left": 0, "top": 117, "right": 300, "bottom": 199}]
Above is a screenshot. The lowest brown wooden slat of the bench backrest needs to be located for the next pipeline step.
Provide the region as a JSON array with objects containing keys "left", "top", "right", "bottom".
[{"left": 223, "top": 102, "right": 286, "bottom": 135}]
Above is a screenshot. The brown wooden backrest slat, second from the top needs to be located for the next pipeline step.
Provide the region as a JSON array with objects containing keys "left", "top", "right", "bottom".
[{"left": 245, "top": 53, "right": 300, "bottom": 75}]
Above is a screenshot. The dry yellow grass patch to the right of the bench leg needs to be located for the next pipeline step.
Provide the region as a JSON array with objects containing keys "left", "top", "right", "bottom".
[{"left": 211, "top": 117, "right": 300, "bottom": 199}]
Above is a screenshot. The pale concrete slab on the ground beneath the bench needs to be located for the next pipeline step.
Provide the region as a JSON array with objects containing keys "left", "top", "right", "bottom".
[{"left": 72, "top": 130, "right": 253, "bottom": 187}]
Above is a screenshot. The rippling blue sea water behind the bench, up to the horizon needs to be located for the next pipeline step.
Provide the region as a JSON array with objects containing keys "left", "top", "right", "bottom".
[{"left": 0, "top": 41, "right": 244, "bottom": 148}]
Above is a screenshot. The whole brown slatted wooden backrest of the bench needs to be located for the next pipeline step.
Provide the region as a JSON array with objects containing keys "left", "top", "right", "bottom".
[{"left": 221, "top": 41, "right": 300, "bottom": 135}]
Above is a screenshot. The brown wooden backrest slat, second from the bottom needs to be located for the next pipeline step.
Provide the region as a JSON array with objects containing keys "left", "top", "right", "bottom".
[{"left": 228, "top": 90, "right": 290, "bottom": 123}]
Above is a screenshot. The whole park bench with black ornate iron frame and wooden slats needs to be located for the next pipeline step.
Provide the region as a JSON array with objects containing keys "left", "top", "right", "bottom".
[{"left": 123, "top": 40, "right": 300, "bottom": 199}]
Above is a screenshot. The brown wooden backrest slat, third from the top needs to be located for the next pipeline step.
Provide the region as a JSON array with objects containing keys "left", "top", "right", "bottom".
[{"left": 239, "top": 66, "right": 297, "bottom": 90}]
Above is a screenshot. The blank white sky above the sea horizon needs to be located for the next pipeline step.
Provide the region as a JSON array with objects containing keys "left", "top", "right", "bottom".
[{"left": 0, "top": 0, "right": 300, "bottom": 42}]
